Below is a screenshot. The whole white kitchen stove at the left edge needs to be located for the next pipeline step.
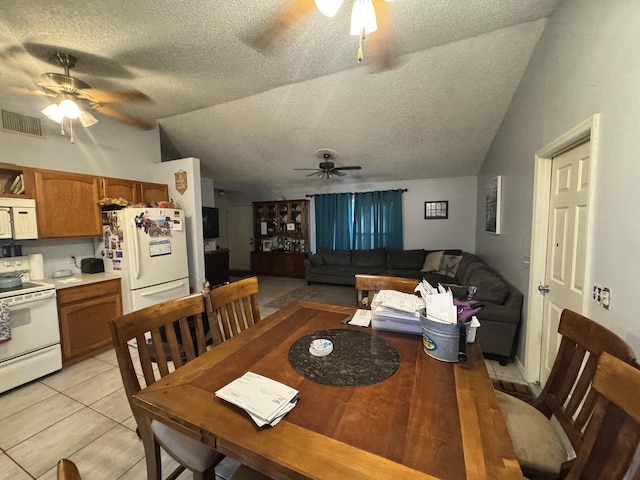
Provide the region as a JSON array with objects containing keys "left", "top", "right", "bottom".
[{"left": 0, "top": 257, "right": 62, "bottom": 393}]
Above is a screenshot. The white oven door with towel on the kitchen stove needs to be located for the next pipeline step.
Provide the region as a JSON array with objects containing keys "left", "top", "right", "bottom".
[{"left": 0, "top": 290, "right": 60, "bottom": 362}]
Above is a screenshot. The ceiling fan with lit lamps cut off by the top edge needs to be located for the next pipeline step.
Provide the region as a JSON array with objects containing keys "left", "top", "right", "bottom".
[{"left": 247, "top": 0, "right": 397, "bottom": 71}]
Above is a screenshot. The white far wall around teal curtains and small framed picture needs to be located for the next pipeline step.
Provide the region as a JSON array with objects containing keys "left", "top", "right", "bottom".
[{"left": 258, "top": 177, "right": 476, "bottom": 253}]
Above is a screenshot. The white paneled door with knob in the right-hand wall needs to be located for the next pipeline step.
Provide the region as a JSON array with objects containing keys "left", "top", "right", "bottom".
[{"left": 540, "top": 141, "right": 591, "bottom": 385}]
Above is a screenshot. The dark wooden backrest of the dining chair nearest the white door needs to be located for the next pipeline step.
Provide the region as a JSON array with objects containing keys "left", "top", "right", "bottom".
[{"left": 533, "top": 309, "right": 635, "bottom": 451}]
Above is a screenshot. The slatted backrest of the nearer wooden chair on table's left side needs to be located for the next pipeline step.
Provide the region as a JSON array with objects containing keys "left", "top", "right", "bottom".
[{"left": 109, "top": 293, "right": 208, "bottom": 398}]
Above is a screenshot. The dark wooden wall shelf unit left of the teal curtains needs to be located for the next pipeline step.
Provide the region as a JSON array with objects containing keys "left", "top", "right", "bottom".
[{"left": 251, "top": 200, "right": 309, "bottom": 278}]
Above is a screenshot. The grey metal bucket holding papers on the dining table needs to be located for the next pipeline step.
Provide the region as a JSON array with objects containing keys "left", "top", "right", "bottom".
[{"left": 420, "top": 308, "right": 471, "bottom": 362}]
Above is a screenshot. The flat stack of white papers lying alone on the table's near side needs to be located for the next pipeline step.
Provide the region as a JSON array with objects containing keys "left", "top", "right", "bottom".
[{"left": 216, "top": 372, "right": 299, "bottom": 427}]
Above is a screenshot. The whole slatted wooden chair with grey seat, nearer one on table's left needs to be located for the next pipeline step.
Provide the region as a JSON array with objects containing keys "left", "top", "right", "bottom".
[{"left": 109, "top": 293, "right": 224, "bottom": 480}]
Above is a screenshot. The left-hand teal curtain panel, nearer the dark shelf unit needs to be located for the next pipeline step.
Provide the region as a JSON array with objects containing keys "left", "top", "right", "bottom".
[{"left": 314, "top": 193, "right": 353, "bottom": 250}]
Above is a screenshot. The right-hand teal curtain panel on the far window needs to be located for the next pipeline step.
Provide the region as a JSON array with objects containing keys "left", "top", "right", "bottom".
[{"left": 351, "top": 190, "right": 403, "bottom": 250}]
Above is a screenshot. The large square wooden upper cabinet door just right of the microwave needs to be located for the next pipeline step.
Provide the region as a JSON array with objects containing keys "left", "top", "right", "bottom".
[{"left": 34, "top": 169, "right": 102, "bottom": 238}]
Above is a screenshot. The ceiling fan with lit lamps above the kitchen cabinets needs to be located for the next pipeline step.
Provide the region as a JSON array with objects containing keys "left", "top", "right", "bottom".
[{"left": 12, "top": 53, "right": 153, "bottom": 142}]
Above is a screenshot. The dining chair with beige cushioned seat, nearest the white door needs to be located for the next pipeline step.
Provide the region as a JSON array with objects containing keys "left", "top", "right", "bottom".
[{"left": 496, "top": 309, "right": 635, "bottom": 480}]
